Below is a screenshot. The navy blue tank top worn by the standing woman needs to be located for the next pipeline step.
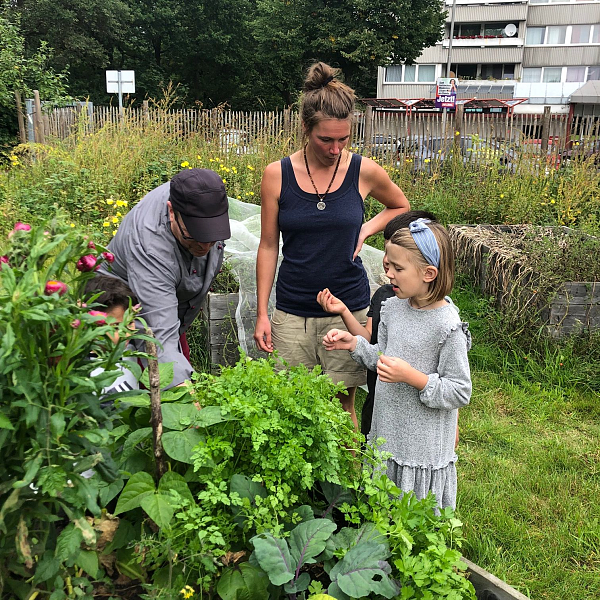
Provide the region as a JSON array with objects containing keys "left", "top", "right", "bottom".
[{"left": 275, "top": 154, "right": 370, "bottom": 317}]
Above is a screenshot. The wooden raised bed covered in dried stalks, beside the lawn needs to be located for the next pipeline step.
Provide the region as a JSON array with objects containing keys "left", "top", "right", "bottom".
[{"left": 448, "top": 225, "right": 600, "bottom": 338}]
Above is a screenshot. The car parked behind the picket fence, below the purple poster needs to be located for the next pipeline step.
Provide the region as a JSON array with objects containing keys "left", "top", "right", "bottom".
[{"left": 397, "top": 135, "right": 516, "bottom": 171}]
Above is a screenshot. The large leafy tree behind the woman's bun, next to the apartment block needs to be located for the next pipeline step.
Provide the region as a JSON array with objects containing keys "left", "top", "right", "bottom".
[{"left": 253, "top": 0, "right": 445, "bottom": 103}]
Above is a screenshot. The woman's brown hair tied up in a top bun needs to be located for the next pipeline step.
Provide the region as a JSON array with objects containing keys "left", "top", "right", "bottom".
[{"left": 300, "top": 62, "right": 356, "bottom": 135}]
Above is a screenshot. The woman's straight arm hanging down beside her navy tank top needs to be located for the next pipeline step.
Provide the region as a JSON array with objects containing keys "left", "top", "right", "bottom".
[{"left": 254, "top": 162, "right": 281, "bottom": 352}]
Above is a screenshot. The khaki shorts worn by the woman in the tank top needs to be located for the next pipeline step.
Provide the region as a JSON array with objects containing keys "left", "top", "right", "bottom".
[{"left": 271, "top": 308, "right": 368, "bottom": 387}]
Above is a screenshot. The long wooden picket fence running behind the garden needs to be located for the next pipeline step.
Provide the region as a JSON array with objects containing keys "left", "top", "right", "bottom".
[{"left": 34, "top": 102, "right": 600, "bottom": 165}]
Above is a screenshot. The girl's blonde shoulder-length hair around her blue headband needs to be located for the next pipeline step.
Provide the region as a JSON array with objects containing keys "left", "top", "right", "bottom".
[{"left": 389, "top": 222, "right": 454, "bottom": 303}]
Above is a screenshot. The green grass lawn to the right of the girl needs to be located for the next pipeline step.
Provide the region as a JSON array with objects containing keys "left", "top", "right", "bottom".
[{"left": 356, "top": 287, "right": 600, "bottom": 600}]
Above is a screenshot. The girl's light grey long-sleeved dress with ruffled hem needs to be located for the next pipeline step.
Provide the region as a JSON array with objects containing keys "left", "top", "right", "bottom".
[{"left": 351, "top": 297, "right": 471, "bottom": 508}]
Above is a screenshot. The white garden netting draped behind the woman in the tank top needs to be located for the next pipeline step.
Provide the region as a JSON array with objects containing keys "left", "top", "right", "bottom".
[{"left": 225, "top": 198, "right": 383, "bottom": 356}]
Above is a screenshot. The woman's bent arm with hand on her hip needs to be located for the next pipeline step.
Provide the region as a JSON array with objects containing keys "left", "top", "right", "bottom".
[{"left": 354, "top": 158, "right": 410, "bottom": 258}]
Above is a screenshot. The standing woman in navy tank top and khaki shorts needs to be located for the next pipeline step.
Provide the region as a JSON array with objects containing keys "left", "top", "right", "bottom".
[{"left": 254, "top": 62, "right": 410, "bottom": 426}]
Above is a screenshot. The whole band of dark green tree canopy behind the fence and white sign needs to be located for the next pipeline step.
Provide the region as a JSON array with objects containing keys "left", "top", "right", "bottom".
[{"left": 4, "top": 0, "right": 444, "bottom": 109}]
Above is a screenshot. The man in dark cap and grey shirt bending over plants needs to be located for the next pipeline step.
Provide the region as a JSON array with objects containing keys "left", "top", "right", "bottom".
[{"left": 100, "top": 169, "right": 231, "bottom": 385}]
